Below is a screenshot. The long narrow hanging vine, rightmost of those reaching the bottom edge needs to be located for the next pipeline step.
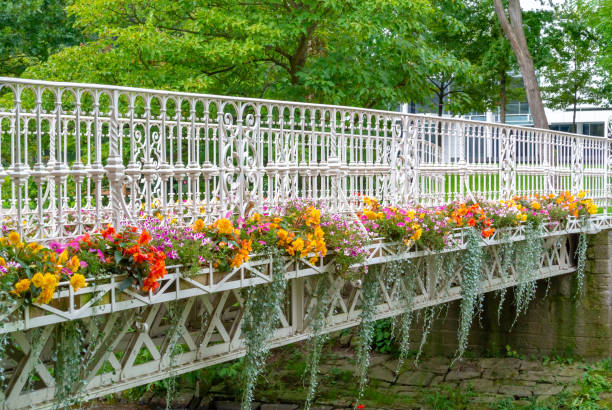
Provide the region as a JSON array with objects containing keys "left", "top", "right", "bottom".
[{"left": 356, "top": 265, "right": 381, "bottom": 403}]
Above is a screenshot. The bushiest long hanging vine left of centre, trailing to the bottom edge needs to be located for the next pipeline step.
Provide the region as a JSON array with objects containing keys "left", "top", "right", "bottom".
[{"left": 241, "top": 248, "right": 287, "bottom": 410}]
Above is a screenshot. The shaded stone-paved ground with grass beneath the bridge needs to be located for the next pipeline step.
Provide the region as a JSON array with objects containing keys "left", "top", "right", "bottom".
[{"left": 90, "top": 345, "right": 612, "bottom": 410}]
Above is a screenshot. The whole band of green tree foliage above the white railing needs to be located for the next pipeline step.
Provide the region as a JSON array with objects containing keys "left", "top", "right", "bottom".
[{"left": 8, "top": 0, "right": 612, "bottom": 121}]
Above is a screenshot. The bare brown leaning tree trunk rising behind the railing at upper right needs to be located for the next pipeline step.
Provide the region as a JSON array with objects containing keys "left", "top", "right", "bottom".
[{"left": 493, "top": 0, "right": 548, "bottom": 128}]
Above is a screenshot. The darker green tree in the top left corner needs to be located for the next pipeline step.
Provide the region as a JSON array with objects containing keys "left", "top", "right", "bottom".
[{"left": 0, "top": 0, "right": 83, "bottom": 76}]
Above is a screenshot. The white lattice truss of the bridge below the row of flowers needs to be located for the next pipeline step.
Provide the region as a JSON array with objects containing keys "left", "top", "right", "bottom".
[{"left": 0, "top": 218, "right": 612, "bottom": 409}]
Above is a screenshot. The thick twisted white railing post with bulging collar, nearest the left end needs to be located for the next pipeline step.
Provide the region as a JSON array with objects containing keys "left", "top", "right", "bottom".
[{"left": 105, "top": 90, "right": 126, "bottom": 227}]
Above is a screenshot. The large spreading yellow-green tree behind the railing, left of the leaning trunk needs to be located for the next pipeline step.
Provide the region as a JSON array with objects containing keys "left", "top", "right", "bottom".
[{"left": 27, "top": 0, "right": 442, "bottom": 108}]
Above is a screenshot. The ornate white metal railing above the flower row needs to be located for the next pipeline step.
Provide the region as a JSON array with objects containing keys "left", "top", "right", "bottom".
[{"left": 0, "top": 77, "right": 612, "bottom": 239}]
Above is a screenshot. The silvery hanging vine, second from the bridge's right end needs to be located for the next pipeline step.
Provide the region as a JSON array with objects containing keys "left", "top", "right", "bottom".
[{"left": 512, "top": 222, "right": 543, "bottom": 327}]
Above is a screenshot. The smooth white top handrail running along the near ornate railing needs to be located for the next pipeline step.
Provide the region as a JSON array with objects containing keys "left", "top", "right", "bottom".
[{"left": 0, "top": 76, "right": 607, "bottom": 140}]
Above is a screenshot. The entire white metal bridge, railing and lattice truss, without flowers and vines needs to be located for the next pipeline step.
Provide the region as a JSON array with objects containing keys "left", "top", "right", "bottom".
[{"left": 0, "top": 78, "right": 612, "bottom": 409}]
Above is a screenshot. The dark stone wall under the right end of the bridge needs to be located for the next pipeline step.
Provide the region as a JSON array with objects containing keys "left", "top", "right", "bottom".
[{"left": 412, "top": 231, "right": 612, "bottom": 358}]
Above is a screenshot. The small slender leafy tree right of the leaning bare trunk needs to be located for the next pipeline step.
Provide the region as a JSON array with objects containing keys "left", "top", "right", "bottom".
[{"left": 542, "top": 0, "right": 605, "bottom": 131}]
